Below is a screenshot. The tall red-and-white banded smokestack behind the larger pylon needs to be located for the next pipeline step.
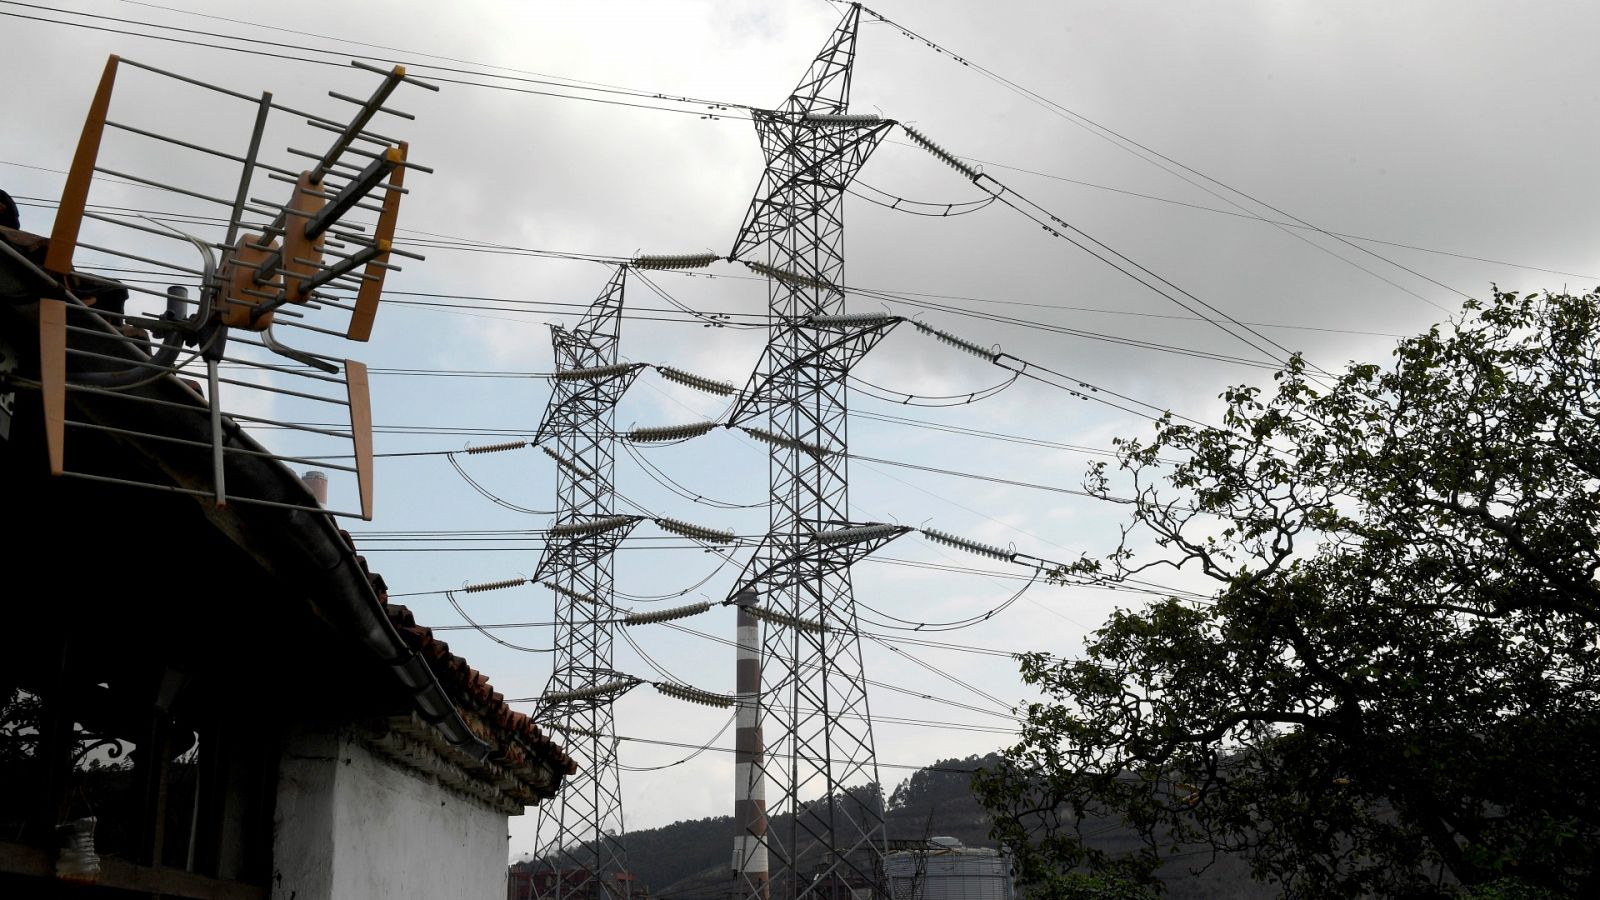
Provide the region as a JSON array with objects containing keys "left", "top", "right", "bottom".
[{"left": 733, "top": 591, "right": 771, "bottom": 900}]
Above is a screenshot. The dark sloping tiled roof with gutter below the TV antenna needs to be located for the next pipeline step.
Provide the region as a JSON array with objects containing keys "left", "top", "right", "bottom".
[{"left": 0, "top": 225, "right": 576, "bottom": 814}]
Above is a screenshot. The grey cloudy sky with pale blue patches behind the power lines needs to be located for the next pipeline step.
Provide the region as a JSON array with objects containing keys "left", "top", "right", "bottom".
[{"left": 0, "top": 0, "right": 1600, "bottom": 854}]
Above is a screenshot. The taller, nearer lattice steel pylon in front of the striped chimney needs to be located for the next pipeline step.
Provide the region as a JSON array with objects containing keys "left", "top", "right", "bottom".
[{"left": 730, "top": 6, "right": 907, "bottom": 898}]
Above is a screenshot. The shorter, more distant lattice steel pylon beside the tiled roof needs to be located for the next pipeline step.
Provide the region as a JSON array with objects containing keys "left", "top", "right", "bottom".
[{"left": 534, "top": 267, "right": 640, "bottom": 898}]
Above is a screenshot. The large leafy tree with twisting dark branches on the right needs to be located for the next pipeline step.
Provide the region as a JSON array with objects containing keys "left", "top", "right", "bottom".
[{"left": 978, "top": 288, "right": 1600, "bottom": 897}]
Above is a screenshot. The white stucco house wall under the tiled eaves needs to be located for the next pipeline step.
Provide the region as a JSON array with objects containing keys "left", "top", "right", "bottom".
[{"left": 272, "top": 733, "right": 507, "bottom": 900}]
